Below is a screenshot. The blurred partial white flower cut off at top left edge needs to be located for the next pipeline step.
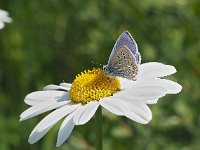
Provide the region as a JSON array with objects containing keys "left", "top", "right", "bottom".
[{"left": 0, "top": 9, "right": 12, "bottom": 30}]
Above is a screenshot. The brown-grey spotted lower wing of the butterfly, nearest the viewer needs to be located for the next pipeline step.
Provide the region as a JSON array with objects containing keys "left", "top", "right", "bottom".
[{"left": 107, "top": 45, "right": 138, "bottom": 80}]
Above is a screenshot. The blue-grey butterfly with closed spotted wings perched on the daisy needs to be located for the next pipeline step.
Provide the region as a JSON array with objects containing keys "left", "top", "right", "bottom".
[{"left": 103, "top": 31, "right": 141, "bottom": 80}]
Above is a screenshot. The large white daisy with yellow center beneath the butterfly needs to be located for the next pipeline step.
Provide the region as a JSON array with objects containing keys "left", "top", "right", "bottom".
[{"left": 20, "top": 62, "right": 182, "bottom": 147}]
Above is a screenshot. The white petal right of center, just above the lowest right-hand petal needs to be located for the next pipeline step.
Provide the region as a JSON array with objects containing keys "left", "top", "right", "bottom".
[{"left": 113, "top": 84, "right": 166, "bottom": 101}]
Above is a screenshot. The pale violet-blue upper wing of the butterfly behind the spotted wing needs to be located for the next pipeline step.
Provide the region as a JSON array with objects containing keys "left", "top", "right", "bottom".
[{"left": 108, "top": 31, "right": 141, "bottom": 64}]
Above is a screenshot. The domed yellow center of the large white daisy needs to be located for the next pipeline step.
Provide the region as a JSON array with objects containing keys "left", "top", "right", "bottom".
[{"left": 69, "top": 68, "right": 120, "bottom": 104}]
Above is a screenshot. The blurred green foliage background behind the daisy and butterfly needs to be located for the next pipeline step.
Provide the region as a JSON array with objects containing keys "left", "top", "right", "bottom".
[{"left": 0, "top": 0, "right": 200, "bottom": 150}]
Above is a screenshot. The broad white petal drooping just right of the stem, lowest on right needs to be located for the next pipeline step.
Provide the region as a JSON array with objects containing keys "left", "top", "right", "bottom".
[{"left": 99, "top": 97, "right": 152, "bottom": 124}]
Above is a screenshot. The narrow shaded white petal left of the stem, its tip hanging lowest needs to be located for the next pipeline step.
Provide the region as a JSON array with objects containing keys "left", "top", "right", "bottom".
[{"left": 56, "top": 113, "right": 74, "bottom": 147}]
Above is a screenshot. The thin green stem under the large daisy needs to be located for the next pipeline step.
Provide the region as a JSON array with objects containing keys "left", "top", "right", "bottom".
[{"left": 95, "top": 106, "right": 102, "bottom": 150}]
